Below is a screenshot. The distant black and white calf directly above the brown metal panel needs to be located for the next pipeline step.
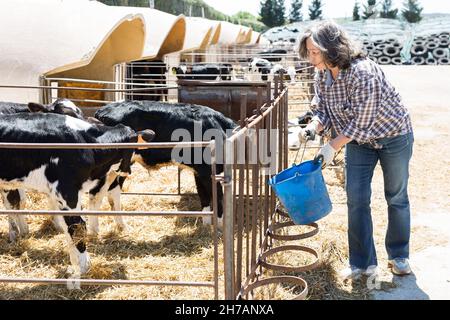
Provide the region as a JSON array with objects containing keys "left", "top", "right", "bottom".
[{"left": 172, "top": 63, "right": 233, "bottom": 80}]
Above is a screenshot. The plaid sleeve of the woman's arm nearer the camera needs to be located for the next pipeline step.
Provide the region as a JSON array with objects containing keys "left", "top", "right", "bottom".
[{"left": 342, "top": 74, "right": 381, "bottom": 143}]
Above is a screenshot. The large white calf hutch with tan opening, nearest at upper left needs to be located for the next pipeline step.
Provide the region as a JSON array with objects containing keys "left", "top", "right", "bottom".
[{"left": 0, "top": 0, "right": 145, "bottom": 102}]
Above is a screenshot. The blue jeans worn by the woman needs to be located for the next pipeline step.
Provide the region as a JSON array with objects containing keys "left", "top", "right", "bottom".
[{"left": 345, "top": 133, "right": 414, "bottom": 269}]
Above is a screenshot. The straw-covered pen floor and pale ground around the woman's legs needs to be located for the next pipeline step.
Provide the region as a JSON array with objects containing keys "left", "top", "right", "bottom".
[{"left": 0, "top": 66, "right": 450, "bottom": 299}]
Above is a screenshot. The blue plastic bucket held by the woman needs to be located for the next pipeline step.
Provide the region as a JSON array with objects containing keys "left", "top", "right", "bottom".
[{"left": 269, "top": 160, "right": 332, "bottom": 224}]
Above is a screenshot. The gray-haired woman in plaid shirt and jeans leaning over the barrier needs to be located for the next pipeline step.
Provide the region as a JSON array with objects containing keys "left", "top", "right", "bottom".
[{"left": 299, "top": 21, "right": 414, "bottom": 279}]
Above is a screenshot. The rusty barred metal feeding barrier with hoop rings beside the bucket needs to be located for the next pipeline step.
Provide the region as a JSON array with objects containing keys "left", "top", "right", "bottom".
[{"left": 217, "top": 79, "right": 319, "bottom": 299}]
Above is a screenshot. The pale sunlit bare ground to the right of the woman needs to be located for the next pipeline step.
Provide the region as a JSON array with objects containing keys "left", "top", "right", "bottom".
[{"left": 373, "top": 66, "right": 450, "bottom": 299}]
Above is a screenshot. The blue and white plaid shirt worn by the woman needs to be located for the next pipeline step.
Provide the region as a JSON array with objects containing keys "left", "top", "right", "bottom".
[{"left": 311, "top": 58, "right": 412, "bottom": 148}]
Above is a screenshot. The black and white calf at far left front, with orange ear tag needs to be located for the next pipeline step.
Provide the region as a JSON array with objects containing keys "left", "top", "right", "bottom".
[{"left": 0, "top": 113, "right": 154, "bottom": 284}]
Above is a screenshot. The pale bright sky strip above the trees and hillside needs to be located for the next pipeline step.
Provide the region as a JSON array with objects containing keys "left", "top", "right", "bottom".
[{"left": 204, "top": 0, "right": 450, "bottom": 18}]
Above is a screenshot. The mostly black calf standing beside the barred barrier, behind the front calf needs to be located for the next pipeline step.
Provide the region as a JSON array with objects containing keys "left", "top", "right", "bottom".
[{"left": 95, "top": 101, "right": 236, "bottom": 223}]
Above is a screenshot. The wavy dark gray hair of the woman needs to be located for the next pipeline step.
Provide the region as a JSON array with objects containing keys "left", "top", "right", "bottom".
[{"left": 299, "top": 21, "right": 366, "bottom": 69}]
